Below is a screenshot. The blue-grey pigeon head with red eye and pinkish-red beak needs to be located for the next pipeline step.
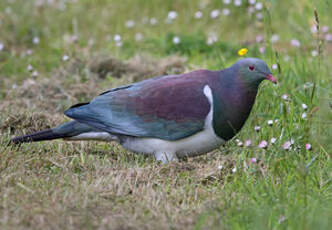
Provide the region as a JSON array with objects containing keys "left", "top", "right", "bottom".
[{"left": 235, "top": 58, "right": 277, "bottom": 87}]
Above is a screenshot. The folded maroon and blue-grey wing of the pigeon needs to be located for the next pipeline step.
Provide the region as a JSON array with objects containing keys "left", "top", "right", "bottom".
[{"left": 65, "top": 70, "right": 210, "bottom": 140}]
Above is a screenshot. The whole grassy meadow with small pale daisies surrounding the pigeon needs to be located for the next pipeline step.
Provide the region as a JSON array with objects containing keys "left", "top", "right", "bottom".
[{"left": 0, "top": 0, "right": 332, "bottom": 230}]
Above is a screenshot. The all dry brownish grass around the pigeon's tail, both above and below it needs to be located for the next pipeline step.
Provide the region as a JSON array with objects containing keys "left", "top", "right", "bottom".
[{"left": 0, "top": 56, "right": 206, "bottom": 229}]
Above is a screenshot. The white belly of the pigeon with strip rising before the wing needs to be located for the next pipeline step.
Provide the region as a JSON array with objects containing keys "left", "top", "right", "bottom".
[{"left": 122, "top": 85, "right": 225, "bottom": 157}]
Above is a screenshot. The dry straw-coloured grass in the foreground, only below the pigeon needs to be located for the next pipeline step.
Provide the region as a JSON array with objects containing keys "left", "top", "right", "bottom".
[{"left": 0, "top": 137, "right": 239, "bottom": 229}]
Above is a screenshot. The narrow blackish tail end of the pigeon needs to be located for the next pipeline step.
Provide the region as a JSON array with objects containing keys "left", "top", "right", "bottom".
[{"left": 11, "top": 129, "right": 68, "bottom": 144}]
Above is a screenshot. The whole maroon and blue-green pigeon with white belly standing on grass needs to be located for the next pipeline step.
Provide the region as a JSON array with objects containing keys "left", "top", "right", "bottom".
[{"left": 11, "top": 58, "right": 277, "bottom": 163}]
